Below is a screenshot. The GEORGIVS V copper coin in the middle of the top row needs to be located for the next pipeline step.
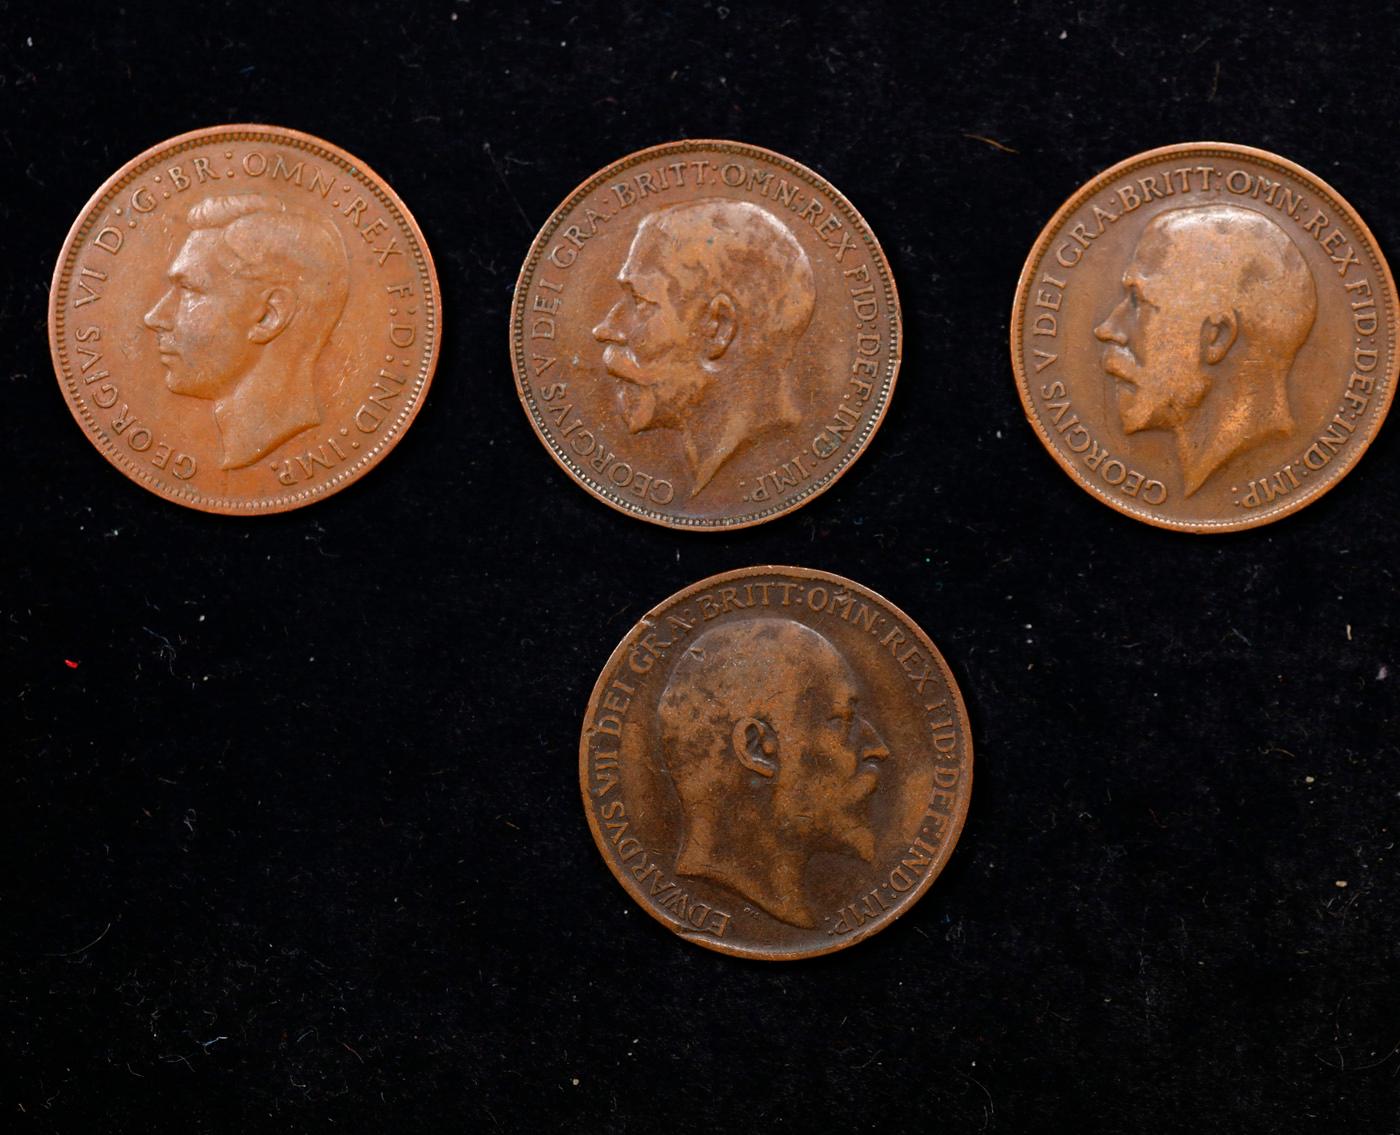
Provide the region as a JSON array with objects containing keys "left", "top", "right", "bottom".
[{"left": 511, "top": 141, "right": 900, "bottom": 529}]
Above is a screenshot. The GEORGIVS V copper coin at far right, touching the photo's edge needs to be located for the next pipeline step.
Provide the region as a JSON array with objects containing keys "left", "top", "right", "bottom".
[{"left": 1011, "top": 143, "right": 1396, "bottom": 532}]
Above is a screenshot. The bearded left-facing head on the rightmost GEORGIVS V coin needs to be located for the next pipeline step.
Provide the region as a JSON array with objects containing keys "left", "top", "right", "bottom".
[{"left": 1093, "top": 204, "right": 1317, "bottom": 497}]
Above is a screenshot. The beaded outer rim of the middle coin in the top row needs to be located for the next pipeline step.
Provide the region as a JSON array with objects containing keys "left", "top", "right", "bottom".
[{"left": 508, "top": 139, "right": 904, "bottom": 532}]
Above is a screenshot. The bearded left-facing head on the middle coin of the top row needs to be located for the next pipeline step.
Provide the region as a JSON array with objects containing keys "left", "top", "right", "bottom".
[{"left": 594, "top": 197, "right": 816, "bottom": 497}]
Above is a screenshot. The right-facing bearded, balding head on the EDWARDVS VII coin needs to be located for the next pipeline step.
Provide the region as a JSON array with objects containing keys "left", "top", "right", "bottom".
[{"left": 657, "top": 617, "right": 889, "bottom": 929}]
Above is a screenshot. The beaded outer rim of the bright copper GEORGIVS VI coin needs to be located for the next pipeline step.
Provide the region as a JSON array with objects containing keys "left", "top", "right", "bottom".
[{"left": 48, "top": 123, "right": 442, "bottom": 516}]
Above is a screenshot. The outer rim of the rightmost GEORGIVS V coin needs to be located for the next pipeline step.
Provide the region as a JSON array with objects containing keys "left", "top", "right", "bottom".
[{"left": 1009, "top": 141, "right": 1400, "bottom": 535}]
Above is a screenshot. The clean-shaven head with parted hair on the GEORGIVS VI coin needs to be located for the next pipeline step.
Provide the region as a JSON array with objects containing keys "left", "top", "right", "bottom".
[{"left": 144, "top": 193, "right": 350, "bottom": 469}]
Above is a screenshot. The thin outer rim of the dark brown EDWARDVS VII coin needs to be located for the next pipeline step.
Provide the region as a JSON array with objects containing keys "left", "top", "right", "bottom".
[{"left": 578, "top": 564, "right": 976, "bottom": 961}]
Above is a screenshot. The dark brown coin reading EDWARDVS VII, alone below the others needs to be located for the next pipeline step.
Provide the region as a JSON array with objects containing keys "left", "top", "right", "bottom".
[{"left": 578, "top": 567, "right": 972, "bottom": 960}]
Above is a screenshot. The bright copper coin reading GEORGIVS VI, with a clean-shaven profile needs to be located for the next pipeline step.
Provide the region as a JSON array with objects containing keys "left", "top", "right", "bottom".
[{"left": 49, "top": 126, "right": 440, "bottom": 515}]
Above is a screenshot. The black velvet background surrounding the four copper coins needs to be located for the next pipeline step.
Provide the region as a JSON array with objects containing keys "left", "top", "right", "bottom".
[{"left": 0, "top": 0, "right": 1400, "bottom": 1132}]
